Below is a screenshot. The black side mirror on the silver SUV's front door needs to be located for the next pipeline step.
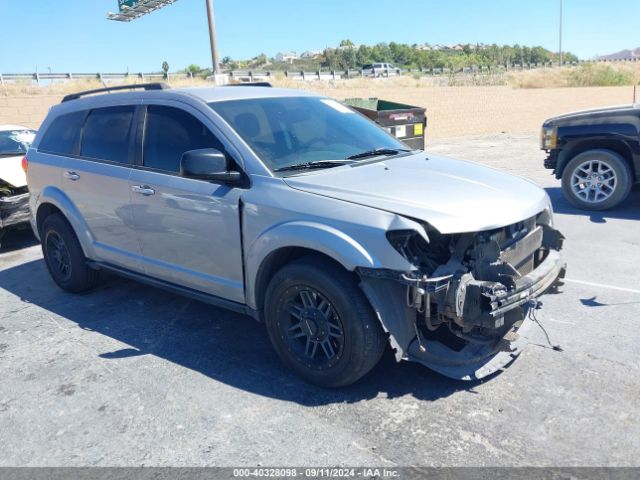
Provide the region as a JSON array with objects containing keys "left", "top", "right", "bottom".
[{"left": 180, "top": 148, "right": 242, "bottom": 183}]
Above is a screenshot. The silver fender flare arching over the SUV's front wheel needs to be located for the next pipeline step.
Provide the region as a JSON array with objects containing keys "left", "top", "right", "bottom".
[{"left": 245, "top": 221, "right": 381, "bottom": 309}]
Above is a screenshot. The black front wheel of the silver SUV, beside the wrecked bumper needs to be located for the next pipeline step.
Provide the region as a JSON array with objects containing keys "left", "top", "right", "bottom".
[{"left": 265, "top": 257, "right": 386, "bottom": 388}]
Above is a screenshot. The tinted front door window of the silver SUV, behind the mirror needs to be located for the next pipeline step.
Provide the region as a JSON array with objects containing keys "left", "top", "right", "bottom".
[{"left": 143, "top": 105, "right": 224, "bottom": 173}]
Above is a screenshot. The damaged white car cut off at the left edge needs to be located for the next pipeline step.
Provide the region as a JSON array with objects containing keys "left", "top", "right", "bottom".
[{"left": 0, "top": 125, "right": 35, "bottom": 242}]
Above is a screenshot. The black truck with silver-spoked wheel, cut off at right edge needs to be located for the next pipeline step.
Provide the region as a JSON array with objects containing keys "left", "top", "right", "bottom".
[{"left": 541, "top": 105, "right": 640, "bottom": 210}]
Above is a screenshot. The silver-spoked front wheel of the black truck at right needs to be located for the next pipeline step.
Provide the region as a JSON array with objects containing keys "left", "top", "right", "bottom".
[{"left": 562, "top": 150, "right": 632, "bottom": 210}]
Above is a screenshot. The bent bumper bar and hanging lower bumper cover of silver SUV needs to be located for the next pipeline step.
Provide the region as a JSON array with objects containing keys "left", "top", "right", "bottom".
[{"left": 406, "top": 251, "right": 566, "bottom": 380}]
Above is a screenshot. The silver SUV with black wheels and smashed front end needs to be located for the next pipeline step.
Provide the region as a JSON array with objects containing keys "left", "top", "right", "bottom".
[{"left": 28, "top": 84, "right": 565, "bottom": 387}]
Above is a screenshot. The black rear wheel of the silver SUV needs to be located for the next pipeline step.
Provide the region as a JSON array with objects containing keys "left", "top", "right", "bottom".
[{"left": 42, "top": 213, "right": 99, "bottom": 293}]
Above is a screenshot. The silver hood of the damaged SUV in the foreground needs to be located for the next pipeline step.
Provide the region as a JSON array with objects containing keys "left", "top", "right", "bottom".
[{"left": 284, "top": 152, "right": 549, "bottom": 233}]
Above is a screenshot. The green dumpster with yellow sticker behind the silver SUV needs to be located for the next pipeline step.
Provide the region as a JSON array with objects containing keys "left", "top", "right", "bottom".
[{"left": 344, "top": 98, "right": 427, "bottom": 150}]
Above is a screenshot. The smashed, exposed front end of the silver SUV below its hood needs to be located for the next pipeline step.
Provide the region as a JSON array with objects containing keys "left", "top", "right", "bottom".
[{"left": 358, "top": 210, "right": 566, "bottom": 380}]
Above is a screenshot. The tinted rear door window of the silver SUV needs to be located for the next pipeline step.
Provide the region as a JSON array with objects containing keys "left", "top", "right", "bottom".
[{"left": 80, "top": 105, "right": 135, "bottom": 163}]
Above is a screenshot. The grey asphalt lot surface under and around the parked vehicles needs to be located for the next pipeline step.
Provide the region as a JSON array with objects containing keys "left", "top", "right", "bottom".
[{"left": 0, "top": 134, "right": 640, "bottom": 466}]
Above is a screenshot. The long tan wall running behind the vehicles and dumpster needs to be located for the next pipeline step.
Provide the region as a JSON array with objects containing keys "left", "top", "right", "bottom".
[{"left": 0, "top": 78, "right": 633, "bottom": 139}]
